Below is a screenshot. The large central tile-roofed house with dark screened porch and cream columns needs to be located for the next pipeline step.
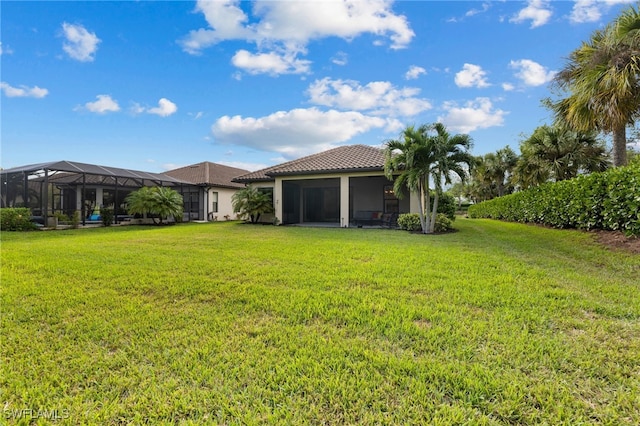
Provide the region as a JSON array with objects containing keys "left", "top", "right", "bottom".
[{"left": 233, "top": 145, "right": 419, "bottom": 228}]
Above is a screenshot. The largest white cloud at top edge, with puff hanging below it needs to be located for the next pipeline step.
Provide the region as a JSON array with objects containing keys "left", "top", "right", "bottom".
[{"left": 179, "top": 0, "right": 414, "bottom": 74}]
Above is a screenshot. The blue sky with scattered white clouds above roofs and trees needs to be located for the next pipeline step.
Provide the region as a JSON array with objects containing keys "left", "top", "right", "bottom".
[{"left": 0, "top": 0, "right": 630, "bottom": 172}]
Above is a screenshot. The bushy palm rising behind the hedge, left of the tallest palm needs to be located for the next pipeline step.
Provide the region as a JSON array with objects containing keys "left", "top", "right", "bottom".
[{"left": 518, "top": 121, "right": 609, "bottom": 187}]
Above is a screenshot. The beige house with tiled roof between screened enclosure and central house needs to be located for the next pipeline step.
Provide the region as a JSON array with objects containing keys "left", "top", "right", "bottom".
[{"left": 165, "top": 161, "right": 249, "bottom": 221}]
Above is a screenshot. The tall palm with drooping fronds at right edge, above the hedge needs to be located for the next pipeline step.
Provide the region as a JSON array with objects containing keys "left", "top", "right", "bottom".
[{"left": 549, "top": 7, "right": 640, "bottom": 166}]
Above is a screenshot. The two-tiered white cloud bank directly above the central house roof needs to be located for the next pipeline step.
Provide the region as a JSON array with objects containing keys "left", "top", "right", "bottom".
[{"left": 211, "top": 78, "right": 432, "bottom": 159}]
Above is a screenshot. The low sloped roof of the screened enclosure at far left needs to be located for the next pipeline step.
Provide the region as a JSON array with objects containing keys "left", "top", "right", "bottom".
[{"left": 0, "top": 161, "right": 188, "bottom": 184}]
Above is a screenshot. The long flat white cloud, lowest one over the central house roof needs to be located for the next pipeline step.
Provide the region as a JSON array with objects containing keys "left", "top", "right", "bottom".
[{"left": 211, "top": 108, "right": 403, "bottom": 158}]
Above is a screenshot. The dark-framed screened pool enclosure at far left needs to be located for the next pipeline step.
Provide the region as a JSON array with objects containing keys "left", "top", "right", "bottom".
[{"left": 0, "top": 161, "right": 204, "bottom": 225}]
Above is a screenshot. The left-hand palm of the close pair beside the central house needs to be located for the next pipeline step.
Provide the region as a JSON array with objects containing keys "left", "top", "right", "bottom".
[{"left": 384, "top": 125, "right": 435, "bottom": 234}]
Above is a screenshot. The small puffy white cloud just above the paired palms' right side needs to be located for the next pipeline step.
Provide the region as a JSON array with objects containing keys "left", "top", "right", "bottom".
[{"left": 438, "top": 98, "right": 508, "bottom": 133}]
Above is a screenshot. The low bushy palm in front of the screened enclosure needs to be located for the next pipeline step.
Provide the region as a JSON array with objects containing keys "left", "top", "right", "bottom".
[{"left": 125, "top": 186, "right": 184, "bottom": 224}]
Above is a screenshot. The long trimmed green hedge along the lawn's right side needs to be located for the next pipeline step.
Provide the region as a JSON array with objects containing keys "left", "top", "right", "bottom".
[{"left": 469, "top": 163, "right": 640, "bottom": 235}]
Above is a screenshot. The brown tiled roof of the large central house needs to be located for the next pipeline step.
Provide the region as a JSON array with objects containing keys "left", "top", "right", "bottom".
[{"left": 234, "top": 145, "right": 385, "bottom": 183}]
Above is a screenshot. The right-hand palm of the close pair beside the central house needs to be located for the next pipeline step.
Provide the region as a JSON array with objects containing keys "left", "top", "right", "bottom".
[{"left": 429, "top": 123, "right": 473, "bottom": 232}]
